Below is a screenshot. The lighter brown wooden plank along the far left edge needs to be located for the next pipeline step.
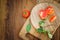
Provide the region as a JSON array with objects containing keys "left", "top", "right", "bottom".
[{"left": 0, "top": 0, "right": 7, "bottom": 40}]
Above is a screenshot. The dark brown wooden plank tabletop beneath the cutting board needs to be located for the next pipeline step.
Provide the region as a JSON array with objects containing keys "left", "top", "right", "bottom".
[{"left": 0, "top": 0, "right": 60, "bottom": 40}]
